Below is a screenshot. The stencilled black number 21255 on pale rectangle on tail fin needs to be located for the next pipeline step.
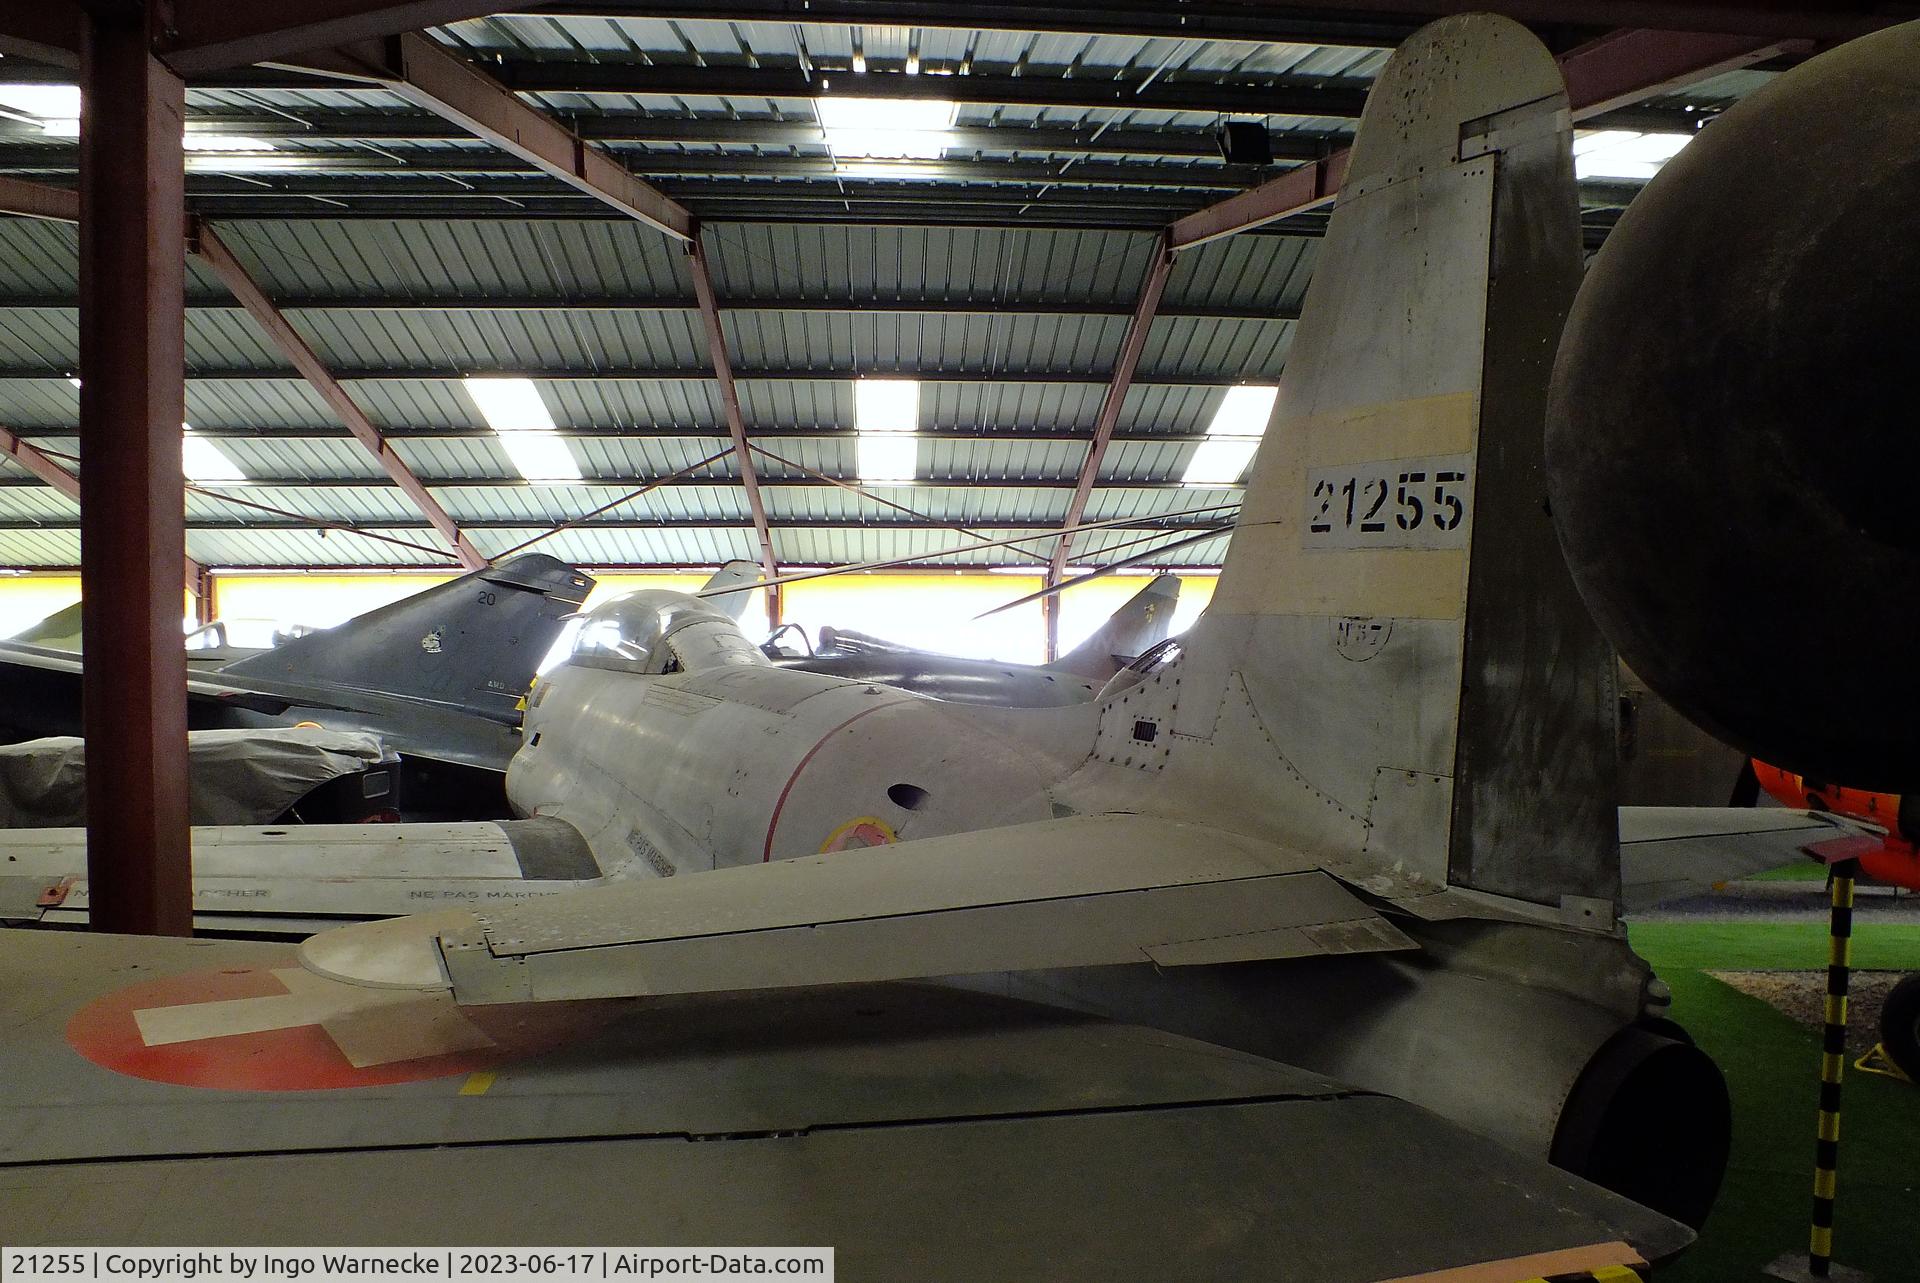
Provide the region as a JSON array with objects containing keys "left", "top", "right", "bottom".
[{"left": 1302, "top": 455, "right": 1473, "bottom": 547}]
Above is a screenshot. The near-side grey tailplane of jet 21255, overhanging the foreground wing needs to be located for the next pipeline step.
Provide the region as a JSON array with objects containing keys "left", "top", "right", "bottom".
[{"left": 301, "top": 814, "right": 1413, "bottom": 1005}]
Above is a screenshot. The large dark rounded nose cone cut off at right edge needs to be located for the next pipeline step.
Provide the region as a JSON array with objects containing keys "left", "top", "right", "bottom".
[{"left": 1546, "top": 23, "right": 1920, "bottom": 791}]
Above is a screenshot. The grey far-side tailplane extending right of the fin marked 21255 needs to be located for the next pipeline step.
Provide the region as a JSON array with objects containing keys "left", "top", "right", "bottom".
[{"left": 1620, "top": 807, "right": 1870, "bottom": 912}]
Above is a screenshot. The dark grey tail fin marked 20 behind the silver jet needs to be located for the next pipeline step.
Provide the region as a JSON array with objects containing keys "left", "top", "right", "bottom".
[{"left": 221, "top": 553, "right": 593, "bottom": 718}]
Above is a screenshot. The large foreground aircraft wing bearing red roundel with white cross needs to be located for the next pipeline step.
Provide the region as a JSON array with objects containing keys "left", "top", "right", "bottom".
[{"left": 0, "top": 921, "right": 1690, "bottom": 1283}]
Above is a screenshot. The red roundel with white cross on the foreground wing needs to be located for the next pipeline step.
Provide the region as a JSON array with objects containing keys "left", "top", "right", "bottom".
[{"left": 67, "top": 951, "right": 614, "bottom": 1091}]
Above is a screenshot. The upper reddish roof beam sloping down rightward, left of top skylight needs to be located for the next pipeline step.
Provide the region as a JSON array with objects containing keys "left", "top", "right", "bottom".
[{"left": 313, "top": 33, "right": 695, "bottom": 240}]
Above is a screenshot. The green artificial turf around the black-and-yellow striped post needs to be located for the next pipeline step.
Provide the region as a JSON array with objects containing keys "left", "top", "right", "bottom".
[{"left": 1628, "top": 922, "right": 1920, "bottom": 1283}]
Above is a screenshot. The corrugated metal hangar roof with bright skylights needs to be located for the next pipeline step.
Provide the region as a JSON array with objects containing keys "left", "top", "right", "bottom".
[{"left": 0, "top": 0, "right": 1791, "bottom": 567}]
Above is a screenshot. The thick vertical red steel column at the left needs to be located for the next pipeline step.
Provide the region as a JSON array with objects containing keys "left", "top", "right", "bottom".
[{"left": 81, "top": 4, "right": 194, "bottom": 935}]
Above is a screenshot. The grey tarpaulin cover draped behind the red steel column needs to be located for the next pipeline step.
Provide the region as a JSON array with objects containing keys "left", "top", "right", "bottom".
[{"left": 0, "top": 726, "right": 386, "bottom": 828}]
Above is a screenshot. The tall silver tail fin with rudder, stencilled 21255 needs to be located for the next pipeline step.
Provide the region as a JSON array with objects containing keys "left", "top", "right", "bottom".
[{"left": 1096, "top": 15, "right": 1619, "bottom": 924}]
